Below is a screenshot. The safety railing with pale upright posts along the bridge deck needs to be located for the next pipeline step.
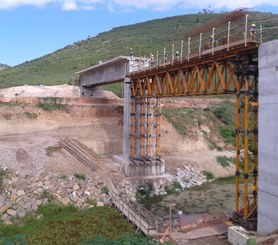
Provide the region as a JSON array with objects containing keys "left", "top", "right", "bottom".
[{"left": 131, "top": 14, "right": 278, "bottom": 73}]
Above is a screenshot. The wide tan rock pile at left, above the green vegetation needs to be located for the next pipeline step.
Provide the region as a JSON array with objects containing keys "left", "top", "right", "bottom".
[{"left": 0, "top": 173, "right": 109, "bottom": 220}]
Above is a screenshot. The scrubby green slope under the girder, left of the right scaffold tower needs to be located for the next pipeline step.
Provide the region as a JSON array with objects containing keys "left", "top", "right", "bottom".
[{"left": 162, "top": 99, "right": 236, "bottom": 150}]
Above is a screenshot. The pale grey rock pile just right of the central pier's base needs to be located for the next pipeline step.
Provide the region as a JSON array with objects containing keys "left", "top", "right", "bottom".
[{"left": 176, "top": 165, "right": 207, "bottom": 189}]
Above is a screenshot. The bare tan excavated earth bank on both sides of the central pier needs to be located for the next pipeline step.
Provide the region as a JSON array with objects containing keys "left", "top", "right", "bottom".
[{"left": 0, "top": 86, "right": 241, "bottom": 245}]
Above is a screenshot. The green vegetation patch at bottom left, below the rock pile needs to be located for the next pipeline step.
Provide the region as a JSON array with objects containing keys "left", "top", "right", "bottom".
[{"left": 0, "top": 204, "right": 156, "bottom": 245}]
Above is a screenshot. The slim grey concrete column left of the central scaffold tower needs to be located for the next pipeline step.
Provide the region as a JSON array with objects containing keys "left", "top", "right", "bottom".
[{"left": 123, "top": 77, "right": 131, "bottom": 160}]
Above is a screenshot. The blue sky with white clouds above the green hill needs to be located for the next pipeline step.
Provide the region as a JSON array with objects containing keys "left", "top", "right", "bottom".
[{"left": 0, "top": 0, "right": 278, "bottom": 66}]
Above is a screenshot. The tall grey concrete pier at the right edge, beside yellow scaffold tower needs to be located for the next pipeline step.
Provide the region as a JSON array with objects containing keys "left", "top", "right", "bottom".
[{"left": 258, "top": 40, "right": 278, "bottom": 234}]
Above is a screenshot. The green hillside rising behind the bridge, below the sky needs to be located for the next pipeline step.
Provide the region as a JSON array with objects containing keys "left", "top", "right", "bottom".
[{"left": 0, "top": 13, "right": 278, "bottom": 88}]
